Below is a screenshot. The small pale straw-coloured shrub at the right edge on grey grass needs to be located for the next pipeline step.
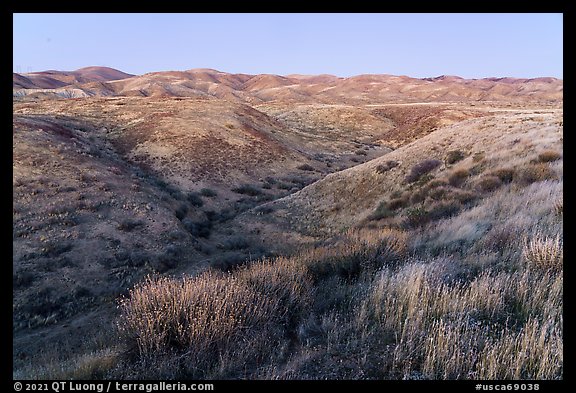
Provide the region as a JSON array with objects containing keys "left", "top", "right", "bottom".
[{"left": 522, "top": 235, "right": 564, "bottom": 270}]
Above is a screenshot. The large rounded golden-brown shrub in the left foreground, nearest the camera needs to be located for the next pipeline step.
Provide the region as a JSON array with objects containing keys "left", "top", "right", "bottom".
[{"left": 118, "top": 272, "right": 278, "bottom": 370}]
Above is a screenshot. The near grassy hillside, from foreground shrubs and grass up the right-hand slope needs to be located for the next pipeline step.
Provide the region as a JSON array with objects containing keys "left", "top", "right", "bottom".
[{"left": 15, "top": 102, "right": 563, "bottom": 379}]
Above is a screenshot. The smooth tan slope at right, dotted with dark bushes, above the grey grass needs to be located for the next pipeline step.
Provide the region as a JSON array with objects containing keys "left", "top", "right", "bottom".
[{"left": 240, "top": 108, "right": 562, "bottom": 250}]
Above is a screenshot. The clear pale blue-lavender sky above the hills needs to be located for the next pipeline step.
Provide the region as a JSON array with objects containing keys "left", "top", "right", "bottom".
[{"left": 13, "top": 13, "right": 563, "bottom": 79}]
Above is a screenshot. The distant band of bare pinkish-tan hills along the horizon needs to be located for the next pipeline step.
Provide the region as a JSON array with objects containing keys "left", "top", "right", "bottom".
[{"left": 13, "top": 67, "right": 564, "bottom": 104}]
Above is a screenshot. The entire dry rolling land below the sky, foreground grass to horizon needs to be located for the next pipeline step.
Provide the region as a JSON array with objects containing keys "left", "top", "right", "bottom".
[{"left": 13, "top": 67, "right": 563, "bottom": 379}]
